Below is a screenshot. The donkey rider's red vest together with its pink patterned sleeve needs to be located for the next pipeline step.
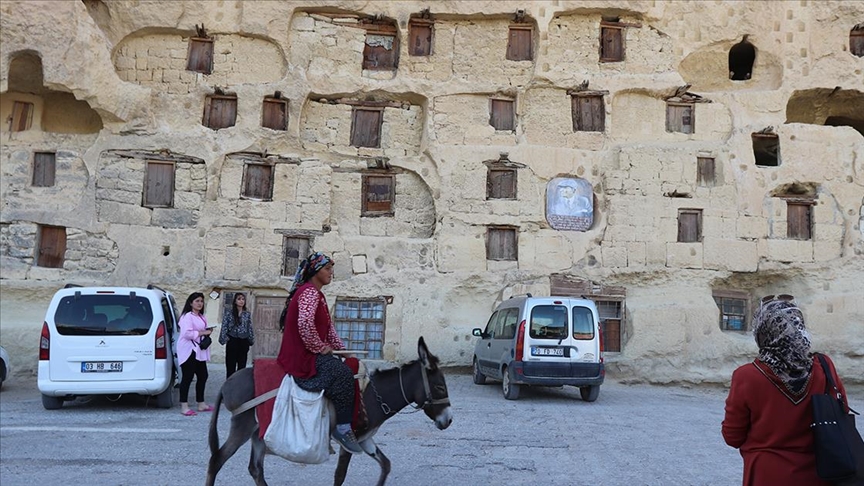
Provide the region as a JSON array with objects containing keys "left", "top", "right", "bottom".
[{"left": 276, "top": 283, "right": 345, "bottom": 378}]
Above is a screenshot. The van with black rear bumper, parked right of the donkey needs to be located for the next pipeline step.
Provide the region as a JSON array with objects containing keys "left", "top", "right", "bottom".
[{"left": 473, "top": 294, "right": 606, "bottom": 402}]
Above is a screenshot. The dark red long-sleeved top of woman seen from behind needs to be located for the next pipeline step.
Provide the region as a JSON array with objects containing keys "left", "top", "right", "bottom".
[{"left": 722, "top": 356, "right": 848, "bottom": 486}]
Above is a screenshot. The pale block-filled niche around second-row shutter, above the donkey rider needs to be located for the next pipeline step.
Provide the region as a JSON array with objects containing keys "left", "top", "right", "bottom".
[{"left": 300, "top": 95, "right": 424, "bottom": 157}]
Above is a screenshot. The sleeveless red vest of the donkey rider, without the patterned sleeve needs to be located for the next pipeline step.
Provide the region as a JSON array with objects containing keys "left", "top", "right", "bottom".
[{"left": 276, "top": 283, "right": 335, "bottom": 378}]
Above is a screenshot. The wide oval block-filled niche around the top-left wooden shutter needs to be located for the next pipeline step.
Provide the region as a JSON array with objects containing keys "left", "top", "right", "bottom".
[{"left": 112, "top": 30, "right": 286, "bottom": 94}]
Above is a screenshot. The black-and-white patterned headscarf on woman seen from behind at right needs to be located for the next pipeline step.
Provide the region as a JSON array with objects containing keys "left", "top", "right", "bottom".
[{"left": 753, "top": 300, "right": 813, "bottom": 392}]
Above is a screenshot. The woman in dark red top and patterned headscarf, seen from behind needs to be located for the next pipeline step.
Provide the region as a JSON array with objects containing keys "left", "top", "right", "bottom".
[{"left": 722, "top": 295, "right": 848, "bottom": 486}]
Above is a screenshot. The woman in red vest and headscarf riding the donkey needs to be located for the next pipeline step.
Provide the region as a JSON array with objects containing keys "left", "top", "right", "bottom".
[{"left": 276, "top": 252, "right": 363, "bottom": 453}]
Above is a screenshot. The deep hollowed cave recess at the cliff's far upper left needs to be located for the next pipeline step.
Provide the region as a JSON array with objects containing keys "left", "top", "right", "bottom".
[{"left": 0, "top": 52, "right": 102, "bottom": 134}]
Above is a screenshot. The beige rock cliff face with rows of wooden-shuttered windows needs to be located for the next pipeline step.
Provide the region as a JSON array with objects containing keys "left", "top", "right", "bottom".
[{"left": 0, "top": 0, "right": 864, "bottom": 383}]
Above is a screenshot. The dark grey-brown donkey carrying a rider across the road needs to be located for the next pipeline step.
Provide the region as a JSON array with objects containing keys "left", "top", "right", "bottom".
[{"left": 205, "top": 337, "right": 453, "bottom": 486}]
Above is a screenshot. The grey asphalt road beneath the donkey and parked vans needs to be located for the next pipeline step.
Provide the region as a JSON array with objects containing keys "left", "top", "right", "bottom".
[{"left": 0, "top": 365, "right": 864, "bottom": 486}]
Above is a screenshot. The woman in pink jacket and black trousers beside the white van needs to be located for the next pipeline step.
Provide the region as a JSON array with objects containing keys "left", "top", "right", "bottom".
[{"left": 177, "top": 292, "right": 213, "bottom": 417}]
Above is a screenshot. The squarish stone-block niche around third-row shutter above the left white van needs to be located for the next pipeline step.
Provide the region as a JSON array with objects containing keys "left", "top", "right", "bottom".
[{"left": 96, "top": 150, "right": 207, "bottom": 228}]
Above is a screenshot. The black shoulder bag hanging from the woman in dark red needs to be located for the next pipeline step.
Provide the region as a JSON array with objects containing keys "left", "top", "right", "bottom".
[{"left": 810, "top": 354, "right": 864, "bottom": 485}]
